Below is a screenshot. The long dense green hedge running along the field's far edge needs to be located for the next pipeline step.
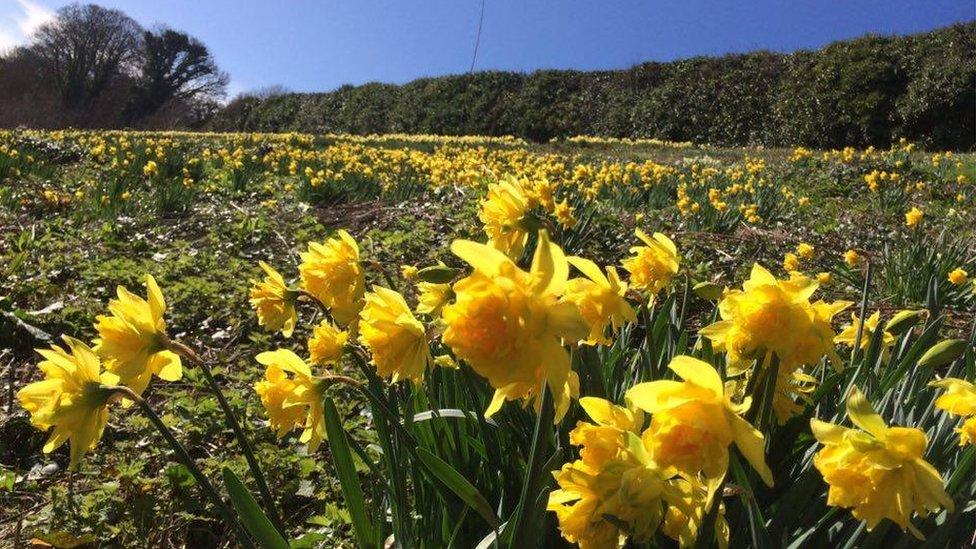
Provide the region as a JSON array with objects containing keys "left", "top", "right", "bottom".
[{"left": 213, "top": 22, "right": 976, "bottom": 150}]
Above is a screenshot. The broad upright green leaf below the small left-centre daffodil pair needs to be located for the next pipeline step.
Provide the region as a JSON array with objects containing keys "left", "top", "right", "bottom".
[{"left": 325, "top": 398, "right": 377, "bottom": 547}]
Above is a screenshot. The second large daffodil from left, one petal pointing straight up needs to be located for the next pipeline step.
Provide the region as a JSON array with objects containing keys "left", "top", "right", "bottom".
[{"left": 94, "top": 275, "right": 183, "bottom": 394}]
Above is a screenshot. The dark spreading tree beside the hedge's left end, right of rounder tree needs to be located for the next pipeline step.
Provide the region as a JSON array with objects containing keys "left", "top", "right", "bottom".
[{"left": 130, "top": 27, "right": 228, "bottom": 118}]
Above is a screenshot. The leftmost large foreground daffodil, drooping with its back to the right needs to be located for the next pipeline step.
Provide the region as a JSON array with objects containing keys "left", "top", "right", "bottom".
[{"left": 17, "top": 336, "right": 118, "bottom": 468}]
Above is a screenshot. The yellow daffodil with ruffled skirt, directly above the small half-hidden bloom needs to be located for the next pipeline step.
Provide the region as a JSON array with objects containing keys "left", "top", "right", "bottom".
[{"left": 299, "top": 231, "right": 366, "bottom": 327}]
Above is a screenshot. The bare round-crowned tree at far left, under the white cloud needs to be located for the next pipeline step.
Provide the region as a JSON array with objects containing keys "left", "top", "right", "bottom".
[{"left": 31, "top": 4, "right": 142, "bottom": 108}]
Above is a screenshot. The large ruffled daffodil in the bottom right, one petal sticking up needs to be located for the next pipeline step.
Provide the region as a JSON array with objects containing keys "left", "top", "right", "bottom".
[{"left": 810, "top": 387, "right": 953, "bottom": 538}]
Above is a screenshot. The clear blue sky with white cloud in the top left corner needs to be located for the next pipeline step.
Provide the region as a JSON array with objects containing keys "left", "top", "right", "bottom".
[{"left": 0, "top": 0, "right": 976, "bottom": 93}]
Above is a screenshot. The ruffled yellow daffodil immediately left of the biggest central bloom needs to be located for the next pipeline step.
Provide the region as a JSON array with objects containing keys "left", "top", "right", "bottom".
[{"left": 359, "top": 286, "right": 434, "bottom": 384}]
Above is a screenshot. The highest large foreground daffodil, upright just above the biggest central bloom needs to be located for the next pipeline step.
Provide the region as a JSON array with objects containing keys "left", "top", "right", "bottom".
[{"left": 478, "top": 177, "right": 530, "bottom": 259}]
